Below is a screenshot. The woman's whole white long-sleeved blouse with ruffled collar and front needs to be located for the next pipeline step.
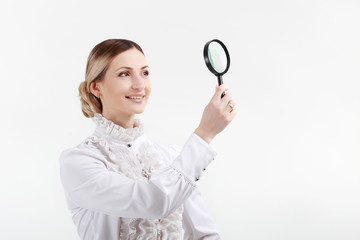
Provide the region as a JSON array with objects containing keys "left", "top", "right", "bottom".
[{"left": 60, "top": 114, "right": 220, "bottom": 240}]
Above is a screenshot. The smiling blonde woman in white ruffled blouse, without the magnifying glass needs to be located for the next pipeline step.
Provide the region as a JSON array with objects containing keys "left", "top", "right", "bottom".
[{"left": 60, "top": 39, "right": 236, "bottom": 240}]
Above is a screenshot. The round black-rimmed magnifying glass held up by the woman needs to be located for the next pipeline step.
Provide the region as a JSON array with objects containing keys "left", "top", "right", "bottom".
[{"left": 204, "top": 39, "right": 230, "bottom": 98}]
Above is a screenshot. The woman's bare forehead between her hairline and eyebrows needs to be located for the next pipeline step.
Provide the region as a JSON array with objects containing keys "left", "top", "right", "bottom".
[{"left": 109, "top": 48, "right": 147, "bottom": 69}]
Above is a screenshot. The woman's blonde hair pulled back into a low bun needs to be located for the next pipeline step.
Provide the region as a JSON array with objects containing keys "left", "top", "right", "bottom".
[{"left": 79, "top": 39, "right": 144, "bottom": 117}]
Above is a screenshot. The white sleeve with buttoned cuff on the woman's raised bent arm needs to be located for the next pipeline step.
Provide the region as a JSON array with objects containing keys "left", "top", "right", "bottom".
[{"left": 60, "top": 134, "right": 215, "bottom": 219}]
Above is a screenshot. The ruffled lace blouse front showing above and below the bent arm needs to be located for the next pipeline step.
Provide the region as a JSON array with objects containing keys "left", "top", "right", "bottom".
[{"left": 85, "top": 133, "right": 183, "bottom": 240}]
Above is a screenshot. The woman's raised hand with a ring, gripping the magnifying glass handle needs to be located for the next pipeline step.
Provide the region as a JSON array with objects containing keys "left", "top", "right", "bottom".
[{"left": 195, "top": 84, "right": 237, "bottom": 143}]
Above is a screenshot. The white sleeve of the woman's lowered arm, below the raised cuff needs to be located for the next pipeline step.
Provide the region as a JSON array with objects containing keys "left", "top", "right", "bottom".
[{"left": 183, "top": 188, "right": 220, "bottom": 240}]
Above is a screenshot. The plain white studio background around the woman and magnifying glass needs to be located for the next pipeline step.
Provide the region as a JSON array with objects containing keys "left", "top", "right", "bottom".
[{"left": 0, "top": 0, "right": 360, "bottom": 240}]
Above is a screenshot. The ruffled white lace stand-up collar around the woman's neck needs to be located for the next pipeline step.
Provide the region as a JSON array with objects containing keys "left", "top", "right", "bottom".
[{"left": 93, "top": 113, "right": 144, "bottom": 142}]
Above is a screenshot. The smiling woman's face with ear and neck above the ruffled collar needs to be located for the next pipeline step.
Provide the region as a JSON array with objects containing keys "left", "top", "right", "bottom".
[{"left": 98, "top": 48, "right": 151, "bottom": 117}]
